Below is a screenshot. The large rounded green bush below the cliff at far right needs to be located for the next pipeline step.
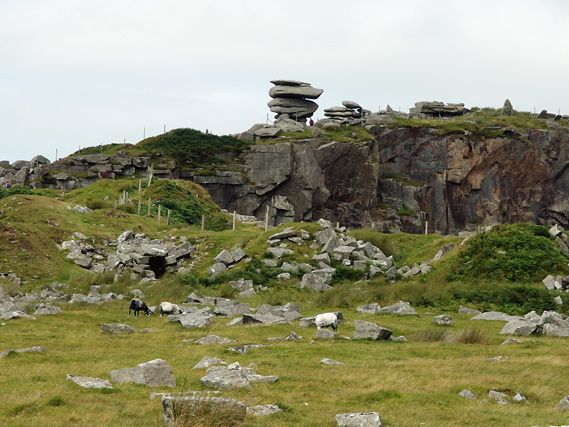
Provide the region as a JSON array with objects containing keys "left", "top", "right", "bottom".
[{"left": 450, "top": 224, "right": 567, "bottom": 282}]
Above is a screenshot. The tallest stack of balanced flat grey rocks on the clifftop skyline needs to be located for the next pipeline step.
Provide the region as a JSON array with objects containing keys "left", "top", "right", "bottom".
[{"left": 267, "top": 80, "right": 324, "bottom": 123}]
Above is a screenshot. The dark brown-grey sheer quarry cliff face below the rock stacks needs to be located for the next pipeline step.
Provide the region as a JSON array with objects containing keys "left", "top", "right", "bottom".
[{"left": 21, "top": 126, "right": 569, "bottom": 234}]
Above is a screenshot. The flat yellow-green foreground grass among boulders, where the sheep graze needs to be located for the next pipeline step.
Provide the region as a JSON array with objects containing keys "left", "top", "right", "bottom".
[{"left": 0, "top": 302, "right": 568, "bottom": 427}]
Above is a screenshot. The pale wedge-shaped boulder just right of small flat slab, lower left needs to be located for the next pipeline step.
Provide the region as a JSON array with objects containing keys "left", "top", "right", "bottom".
[{"left": 111, "top": 359, "right": 176, "bottom": 387}]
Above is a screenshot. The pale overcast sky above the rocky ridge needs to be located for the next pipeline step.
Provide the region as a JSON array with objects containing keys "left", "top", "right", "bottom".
[{"left": 0, "top": 0, "right": 569, "bottom": 163}]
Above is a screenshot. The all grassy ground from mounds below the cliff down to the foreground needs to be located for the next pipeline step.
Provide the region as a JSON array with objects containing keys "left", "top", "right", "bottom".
[{"left": 0, "top": 180, "right": 569, "bottom": 427}]
